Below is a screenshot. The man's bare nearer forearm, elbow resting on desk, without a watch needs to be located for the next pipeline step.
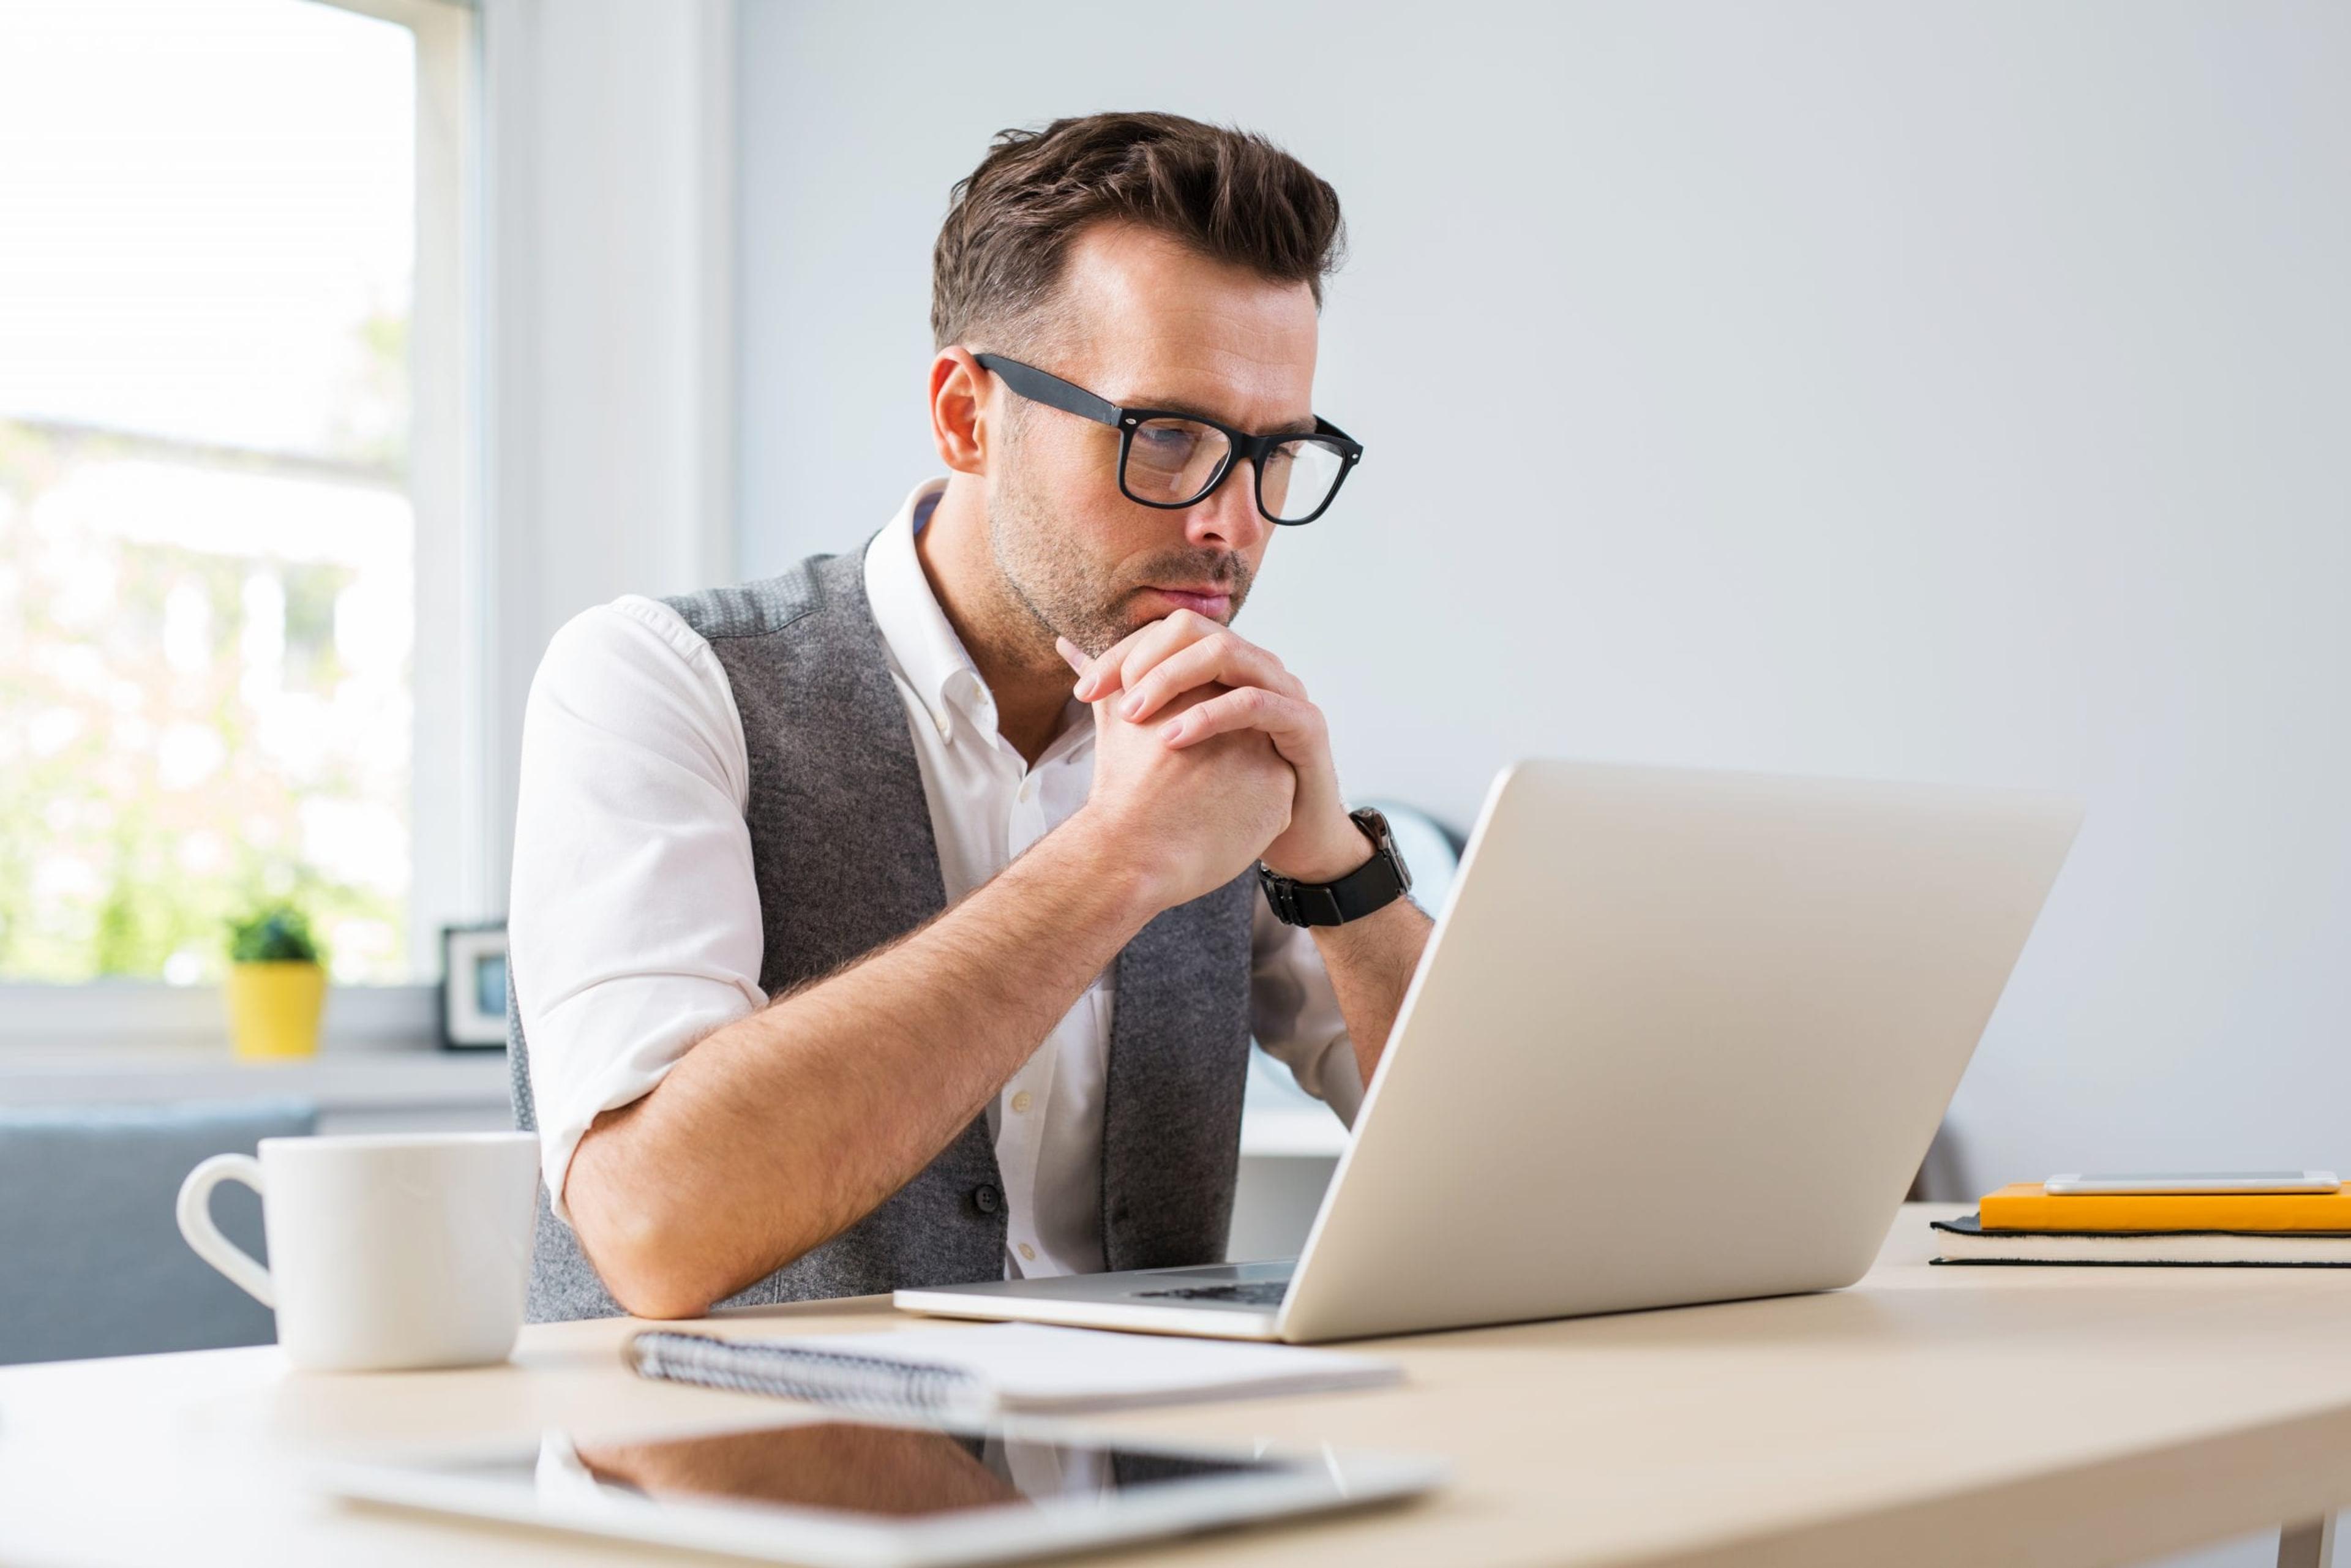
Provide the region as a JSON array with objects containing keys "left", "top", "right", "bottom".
[{"left": 564, "top": 816, "right": 1157, "bottom": 1316}]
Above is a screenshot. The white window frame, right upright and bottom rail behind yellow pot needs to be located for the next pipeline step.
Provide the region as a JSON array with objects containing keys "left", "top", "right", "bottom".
[{"left": 0, "top": 0, "right": 482, "bottom": 1058}]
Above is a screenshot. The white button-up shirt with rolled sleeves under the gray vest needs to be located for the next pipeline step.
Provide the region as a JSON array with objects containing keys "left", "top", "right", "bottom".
[{"left": 508, "top": 479, "right": 1363, "bottom": 1277}]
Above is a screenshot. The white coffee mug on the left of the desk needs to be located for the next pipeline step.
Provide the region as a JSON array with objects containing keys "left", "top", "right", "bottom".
[{"left": 179, "top": 1133, "right": 538, "bottom": 1373}]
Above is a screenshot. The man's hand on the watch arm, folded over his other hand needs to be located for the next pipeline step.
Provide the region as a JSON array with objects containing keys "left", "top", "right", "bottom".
[{"left": 1056, "top": 609, "right": 1373, "bottom": 882}]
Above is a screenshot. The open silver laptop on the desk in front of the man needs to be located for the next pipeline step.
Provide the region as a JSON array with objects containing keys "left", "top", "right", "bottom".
[{"left": 896, "top": 762, "right": 2080, "bottom": 1342}]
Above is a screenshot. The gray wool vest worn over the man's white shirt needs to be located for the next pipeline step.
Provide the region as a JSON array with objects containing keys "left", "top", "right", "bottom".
[{"left": 506, "top": 552, "right": 1258, "bottom": 1321}]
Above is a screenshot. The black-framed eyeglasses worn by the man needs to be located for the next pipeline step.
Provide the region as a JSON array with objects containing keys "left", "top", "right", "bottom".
[{"left": 971, "top": 355, "right": 1363, "bottom": 527}]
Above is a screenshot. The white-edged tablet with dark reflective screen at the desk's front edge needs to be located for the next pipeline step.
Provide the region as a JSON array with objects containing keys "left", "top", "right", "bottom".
[{"left": 313, "top": 1411, "right": 1444, "bottom": 1568}]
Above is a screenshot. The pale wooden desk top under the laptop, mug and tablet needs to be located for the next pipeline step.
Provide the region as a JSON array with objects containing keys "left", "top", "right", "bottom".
[{"left": 0, "top": 1209, "right": 2351, "bottom": 1568}]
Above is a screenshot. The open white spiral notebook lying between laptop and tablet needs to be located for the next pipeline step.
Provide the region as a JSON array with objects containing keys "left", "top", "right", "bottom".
[{"left": 625, "top": 1324, "right": 1403, "bottom": 1417}]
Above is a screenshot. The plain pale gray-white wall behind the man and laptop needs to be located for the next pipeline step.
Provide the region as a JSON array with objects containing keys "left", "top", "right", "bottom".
[{"left": 738, "top": 0, "right": 2351, "bottom": 1222}]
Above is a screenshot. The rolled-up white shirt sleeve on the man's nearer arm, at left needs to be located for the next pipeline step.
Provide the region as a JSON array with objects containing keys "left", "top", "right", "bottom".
[{"left": 508, "top": 597, "right": 767, "bottom": 1225}]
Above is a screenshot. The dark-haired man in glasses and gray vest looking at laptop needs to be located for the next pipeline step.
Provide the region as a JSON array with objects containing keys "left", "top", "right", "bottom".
[{"left": 512, "top": 115, "right": 1430, "bottom": 1319}]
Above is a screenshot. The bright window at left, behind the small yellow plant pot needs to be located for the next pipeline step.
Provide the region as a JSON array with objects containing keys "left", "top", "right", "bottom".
[{"left": 0, "top": 0, "right": 479, "bottom": 1001}]
